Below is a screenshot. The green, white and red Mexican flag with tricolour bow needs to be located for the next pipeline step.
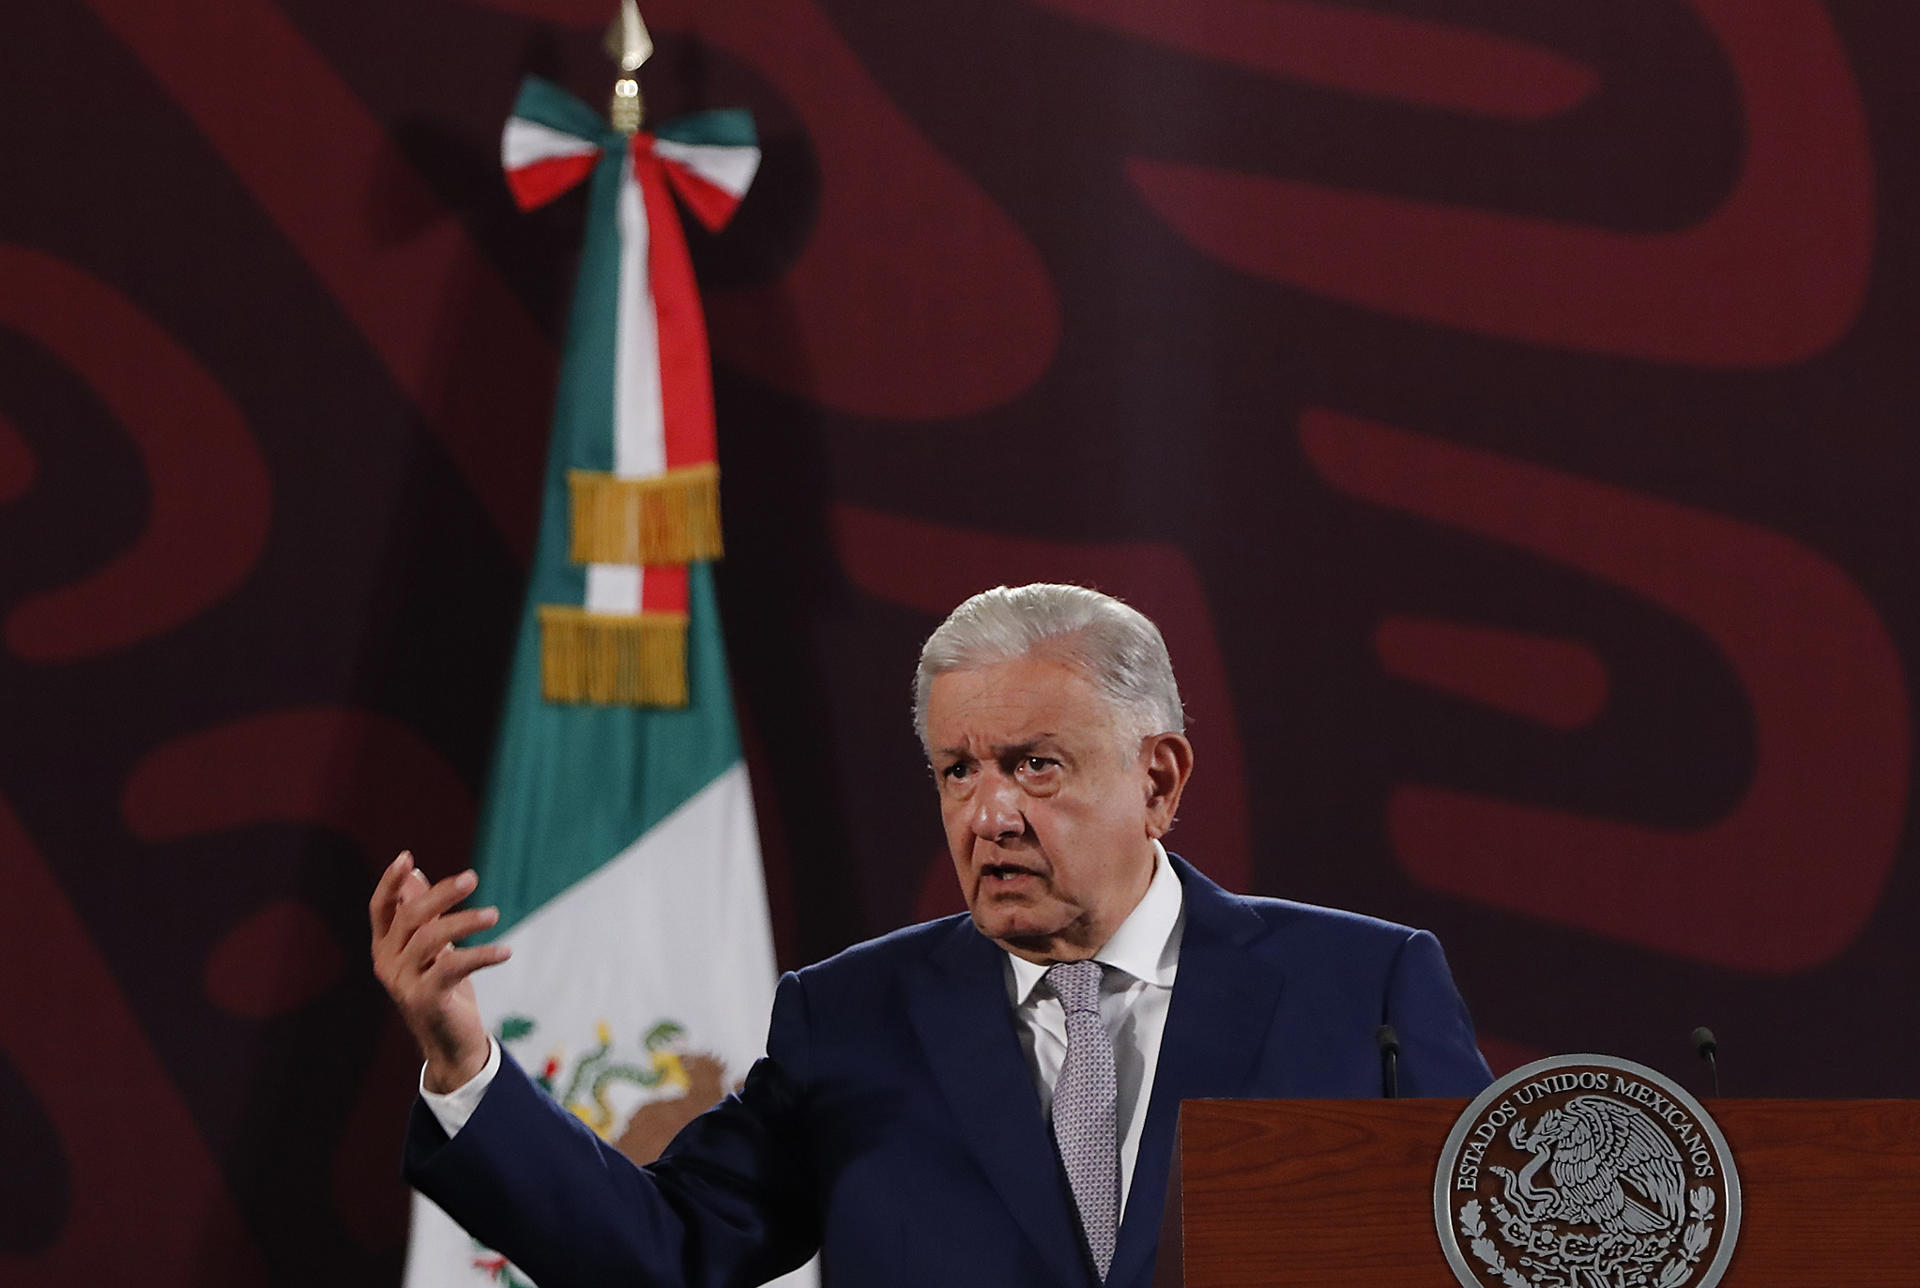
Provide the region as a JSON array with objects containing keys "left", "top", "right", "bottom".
[{"left": 407, "top": 81, "right": 812, "bottom": 1288}]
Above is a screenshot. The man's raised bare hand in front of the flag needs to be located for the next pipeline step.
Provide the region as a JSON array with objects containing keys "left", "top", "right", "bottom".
[{"left": 367, "top": 850, "right": 513, "bottom": 1092}]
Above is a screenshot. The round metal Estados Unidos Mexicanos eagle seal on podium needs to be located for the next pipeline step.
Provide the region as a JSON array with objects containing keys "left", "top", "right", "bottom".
[{"left": 1434, "top": 1056, "right": 1740, "bottom": 1288}]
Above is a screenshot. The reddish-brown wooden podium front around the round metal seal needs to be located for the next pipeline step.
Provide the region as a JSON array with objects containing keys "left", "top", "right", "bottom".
[{"left": 1154, "top": 1100, "right": 1920, "bottom": 1288}]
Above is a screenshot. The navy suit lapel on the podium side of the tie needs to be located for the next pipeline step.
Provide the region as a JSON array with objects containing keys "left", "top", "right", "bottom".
[{"left": 1105, "top": 856, "right": 1284, "bottom": 1284}]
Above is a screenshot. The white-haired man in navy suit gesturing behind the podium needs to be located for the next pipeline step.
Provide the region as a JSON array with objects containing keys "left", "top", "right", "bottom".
[{"left": 371, "top": 585, "right": 1488, "bottom": 1288}]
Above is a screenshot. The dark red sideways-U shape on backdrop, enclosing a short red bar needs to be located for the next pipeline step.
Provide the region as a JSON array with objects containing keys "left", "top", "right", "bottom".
[{"left": 1300, "top": 411, "right": 1910, "bottom": 973}]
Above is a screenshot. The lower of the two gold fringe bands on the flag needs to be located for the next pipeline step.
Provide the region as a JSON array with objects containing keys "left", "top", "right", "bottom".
[{"left": 540, "top": 605, "right": 687, "bottom": 706}]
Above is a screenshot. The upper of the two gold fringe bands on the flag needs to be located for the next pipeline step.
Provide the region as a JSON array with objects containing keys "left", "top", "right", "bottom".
[{"left": 566, "top": 463, "right": 720, "bottom": 564}]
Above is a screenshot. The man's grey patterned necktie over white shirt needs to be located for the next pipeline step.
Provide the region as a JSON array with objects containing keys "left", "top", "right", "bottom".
[{"left": 1046, "top": 962, "right": 1119, "bottom": 1280}]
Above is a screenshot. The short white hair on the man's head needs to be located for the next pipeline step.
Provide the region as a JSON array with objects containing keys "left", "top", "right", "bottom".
[{"left": 914, "top": 582, "right": 1187, "bottom": 752}]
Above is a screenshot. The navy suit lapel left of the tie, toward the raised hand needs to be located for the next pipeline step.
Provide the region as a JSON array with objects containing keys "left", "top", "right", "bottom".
[{"left": 906, "top": 921, "right": 1090, "bottom": 1284}]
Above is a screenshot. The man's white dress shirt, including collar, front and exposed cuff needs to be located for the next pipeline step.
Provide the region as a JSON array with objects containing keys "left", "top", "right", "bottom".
[{"left": 420, "top": 841, "right": 1187, "bottom": 1213}]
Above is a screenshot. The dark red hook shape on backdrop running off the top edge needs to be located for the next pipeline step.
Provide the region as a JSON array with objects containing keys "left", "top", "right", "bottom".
[{"left": 1129, "top": 0, "right": 1874, "bottom": 367}]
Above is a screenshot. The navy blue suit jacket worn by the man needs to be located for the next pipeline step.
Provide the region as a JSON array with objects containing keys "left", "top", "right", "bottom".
[{"left": 407, "top": 858, "right": 1490, "bottom": 1288}]
